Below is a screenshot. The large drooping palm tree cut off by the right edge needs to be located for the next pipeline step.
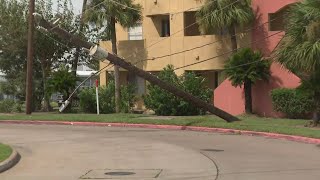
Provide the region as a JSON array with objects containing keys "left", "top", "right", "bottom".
[{"left": 274, "top": 0, "right": 320, "bottom": 126}]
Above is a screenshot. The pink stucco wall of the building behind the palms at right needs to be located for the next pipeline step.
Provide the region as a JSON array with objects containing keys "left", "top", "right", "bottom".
[{"left": 214, "top": 0, "right": 300, "bottom": 117}]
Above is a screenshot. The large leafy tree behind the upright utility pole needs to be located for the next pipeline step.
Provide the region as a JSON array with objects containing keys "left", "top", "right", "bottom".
[{"left": 0, "top": 0, "right": 92, "bottom": 111}]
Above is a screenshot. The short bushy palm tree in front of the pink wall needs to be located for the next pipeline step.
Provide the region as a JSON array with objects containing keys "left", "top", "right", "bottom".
[{"left": 225, "top": 48, "right": 271, "bottom": 114}]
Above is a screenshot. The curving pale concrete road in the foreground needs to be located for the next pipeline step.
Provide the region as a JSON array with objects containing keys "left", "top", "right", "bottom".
[{"left": 0, "top": 124, "right": 320, "bottom": 180}]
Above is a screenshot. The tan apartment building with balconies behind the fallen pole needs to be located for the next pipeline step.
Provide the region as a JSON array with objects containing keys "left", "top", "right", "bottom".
[{"left": 100, "top": 0, "right": 250, "bottom": 97}]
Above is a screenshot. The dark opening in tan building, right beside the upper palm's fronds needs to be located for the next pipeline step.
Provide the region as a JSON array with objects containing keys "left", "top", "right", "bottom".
[{"left": 184, "top": 11, "right": 201, "bottom": 36}]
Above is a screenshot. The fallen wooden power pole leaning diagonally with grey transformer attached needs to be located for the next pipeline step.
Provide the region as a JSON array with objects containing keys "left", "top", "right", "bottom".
[{"left": 35, "top": 13, "right": 240, "bottom": 122}]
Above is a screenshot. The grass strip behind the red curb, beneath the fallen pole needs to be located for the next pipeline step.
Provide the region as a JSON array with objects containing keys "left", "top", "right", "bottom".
[{"left": 0, "top": 113, "right": 320, "bottom": 138}]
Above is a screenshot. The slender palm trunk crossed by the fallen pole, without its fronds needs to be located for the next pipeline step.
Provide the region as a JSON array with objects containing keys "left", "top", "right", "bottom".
[{"left": 110, "top": 17, "right": 120, "bottom": 113}]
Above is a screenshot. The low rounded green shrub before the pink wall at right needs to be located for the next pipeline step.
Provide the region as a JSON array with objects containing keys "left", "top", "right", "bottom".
[{"left": 271, "top": 88, "right": 314, "bottom": 118}]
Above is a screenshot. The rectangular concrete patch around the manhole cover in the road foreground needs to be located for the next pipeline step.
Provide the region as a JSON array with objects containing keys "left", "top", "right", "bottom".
[{"left": 80, "top": 169, "right": 162, "bottom": 180}]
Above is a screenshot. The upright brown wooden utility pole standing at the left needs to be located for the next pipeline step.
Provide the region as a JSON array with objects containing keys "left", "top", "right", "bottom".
[{"left": 26, "top": 0, "right": 35, "bottom": 114}]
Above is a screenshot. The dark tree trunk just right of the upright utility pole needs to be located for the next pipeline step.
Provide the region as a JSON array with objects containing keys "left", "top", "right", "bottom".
[{"left": 41, "top": 61, "right": 52, "bottom": 112}]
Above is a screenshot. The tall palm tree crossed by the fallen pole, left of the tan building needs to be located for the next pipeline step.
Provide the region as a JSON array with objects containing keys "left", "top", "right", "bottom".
[{"left": 85, "top": 0, "right": 142, "bottom": 113}]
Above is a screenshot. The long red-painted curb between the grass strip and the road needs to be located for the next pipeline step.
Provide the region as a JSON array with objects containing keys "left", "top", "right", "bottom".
[{"left": 0, "top": 120, "right": 320, "bottom": 144}]
